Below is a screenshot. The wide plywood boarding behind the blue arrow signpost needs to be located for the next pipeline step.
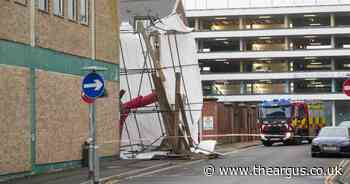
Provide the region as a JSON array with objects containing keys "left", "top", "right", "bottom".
[{"left": 36, "top": 70, "right": 119, "bottom": 164}]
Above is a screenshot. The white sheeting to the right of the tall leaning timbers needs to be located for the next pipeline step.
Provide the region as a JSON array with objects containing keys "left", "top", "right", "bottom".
[{"left": 160, "top": 34, "right": 203, "bottom": 144}]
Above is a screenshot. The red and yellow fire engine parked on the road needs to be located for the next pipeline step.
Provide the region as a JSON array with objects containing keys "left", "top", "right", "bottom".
[{"left": 258, "top": 99, "right": 325, "bottom": 146}]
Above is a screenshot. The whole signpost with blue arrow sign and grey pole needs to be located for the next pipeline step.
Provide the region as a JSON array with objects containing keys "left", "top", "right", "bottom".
[{"left": 81, "top": 67, "right": 106, "bottom": 184}]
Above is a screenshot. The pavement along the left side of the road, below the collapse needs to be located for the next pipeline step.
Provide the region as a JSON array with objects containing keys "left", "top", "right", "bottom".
[{"left": 3, "top": 141, "right": 260, "bottom": 184}]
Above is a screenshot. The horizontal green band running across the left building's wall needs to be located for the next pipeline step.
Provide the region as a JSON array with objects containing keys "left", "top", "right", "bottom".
[{"left": 0, "top": 40, "right": 119, "bottom": 81}]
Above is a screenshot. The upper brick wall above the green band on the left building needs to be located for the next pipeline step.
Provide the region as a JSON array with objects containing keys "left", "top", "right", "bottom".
[{"left": 0, "top": 0, "right": 119, "bottom": 63}]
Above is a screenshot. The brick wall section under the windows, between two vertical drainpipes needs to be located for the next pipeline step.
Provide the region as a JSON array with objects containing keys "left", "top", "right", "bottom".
[{"left": 36, "top": 0, "right": 91, "bottom": 57}]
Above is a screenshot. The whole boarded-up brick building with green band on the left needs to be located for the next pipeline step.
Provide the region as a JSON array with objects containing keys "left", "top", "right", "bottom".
[{"left": 0, "top": 0, "right": 119, "bottom": 180}]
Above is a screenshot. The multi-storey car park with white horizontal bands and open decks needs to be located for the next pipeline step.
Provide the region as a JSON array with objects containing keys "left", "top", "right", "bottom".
[{"left": 184, "top": 0, "right": 350, "bottom": 126}]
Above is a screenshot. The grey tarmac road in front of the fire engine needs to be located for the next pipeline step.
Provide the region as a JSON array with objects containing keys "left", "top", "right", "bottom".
[{"left": 120, "top": 144, "right": 349, "bottom": 184}]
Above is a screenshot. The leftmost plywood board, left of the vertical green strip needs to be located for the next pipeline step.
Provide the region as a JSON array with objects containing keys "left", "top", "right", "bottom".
[{"left": 0, "top": 65, "right": 31, "bottom": 175}]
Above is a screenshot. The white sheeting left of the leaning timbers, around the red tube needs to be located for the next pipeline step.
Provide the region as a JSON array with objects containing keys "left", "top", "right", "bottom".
[{"left": 120, "top": 32, "right": 162, "bottom": 151}]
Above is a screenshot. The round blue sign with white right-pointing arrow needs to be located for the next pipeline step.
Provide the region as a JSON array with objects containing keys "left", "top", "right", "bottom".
[{"left": 82, "top": 72, "right": 105, "bottom": 98}]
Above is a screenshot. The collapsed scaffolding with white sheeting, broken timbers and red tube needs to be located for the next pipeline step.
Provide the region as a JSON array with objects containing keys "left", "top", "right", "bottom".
[{"left": 119, "top": 1, "right": 207, "bottom": 159}]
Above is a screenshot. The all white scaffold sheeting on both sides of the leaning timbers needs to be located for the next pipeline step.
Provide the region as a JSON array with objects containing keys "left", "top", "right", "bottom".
[{"left": 120, "top": 29, "right": 203, "bottom": 154}]
